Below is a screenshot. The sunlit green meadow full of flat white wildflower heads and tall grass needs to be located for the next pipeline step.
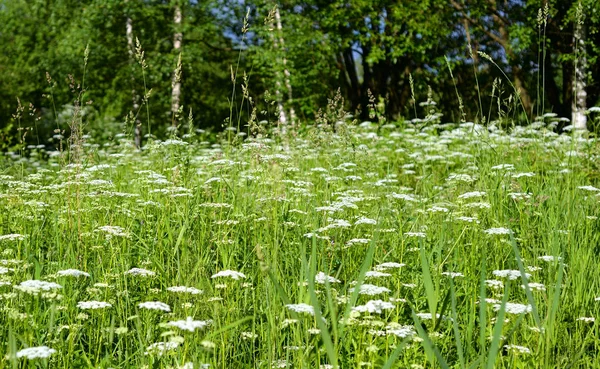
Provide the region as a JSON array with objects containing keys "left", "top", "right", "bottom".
[{"left": 0, "top": 115, "right": 600, "bottom": 369}]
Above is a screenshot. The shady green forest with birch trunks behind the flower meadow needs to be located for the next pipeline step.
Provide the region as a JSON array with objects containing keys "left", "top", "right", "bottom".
[{"left": 0, "top": 0, "right": 600, "bottom": 144}]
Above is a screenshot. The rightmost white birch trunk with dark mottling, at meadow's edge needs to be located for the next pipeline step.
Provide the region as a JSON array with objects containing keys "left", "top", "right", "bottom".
[{"left": 571, "top": 20, "right": 587, "bottom": 131}]
